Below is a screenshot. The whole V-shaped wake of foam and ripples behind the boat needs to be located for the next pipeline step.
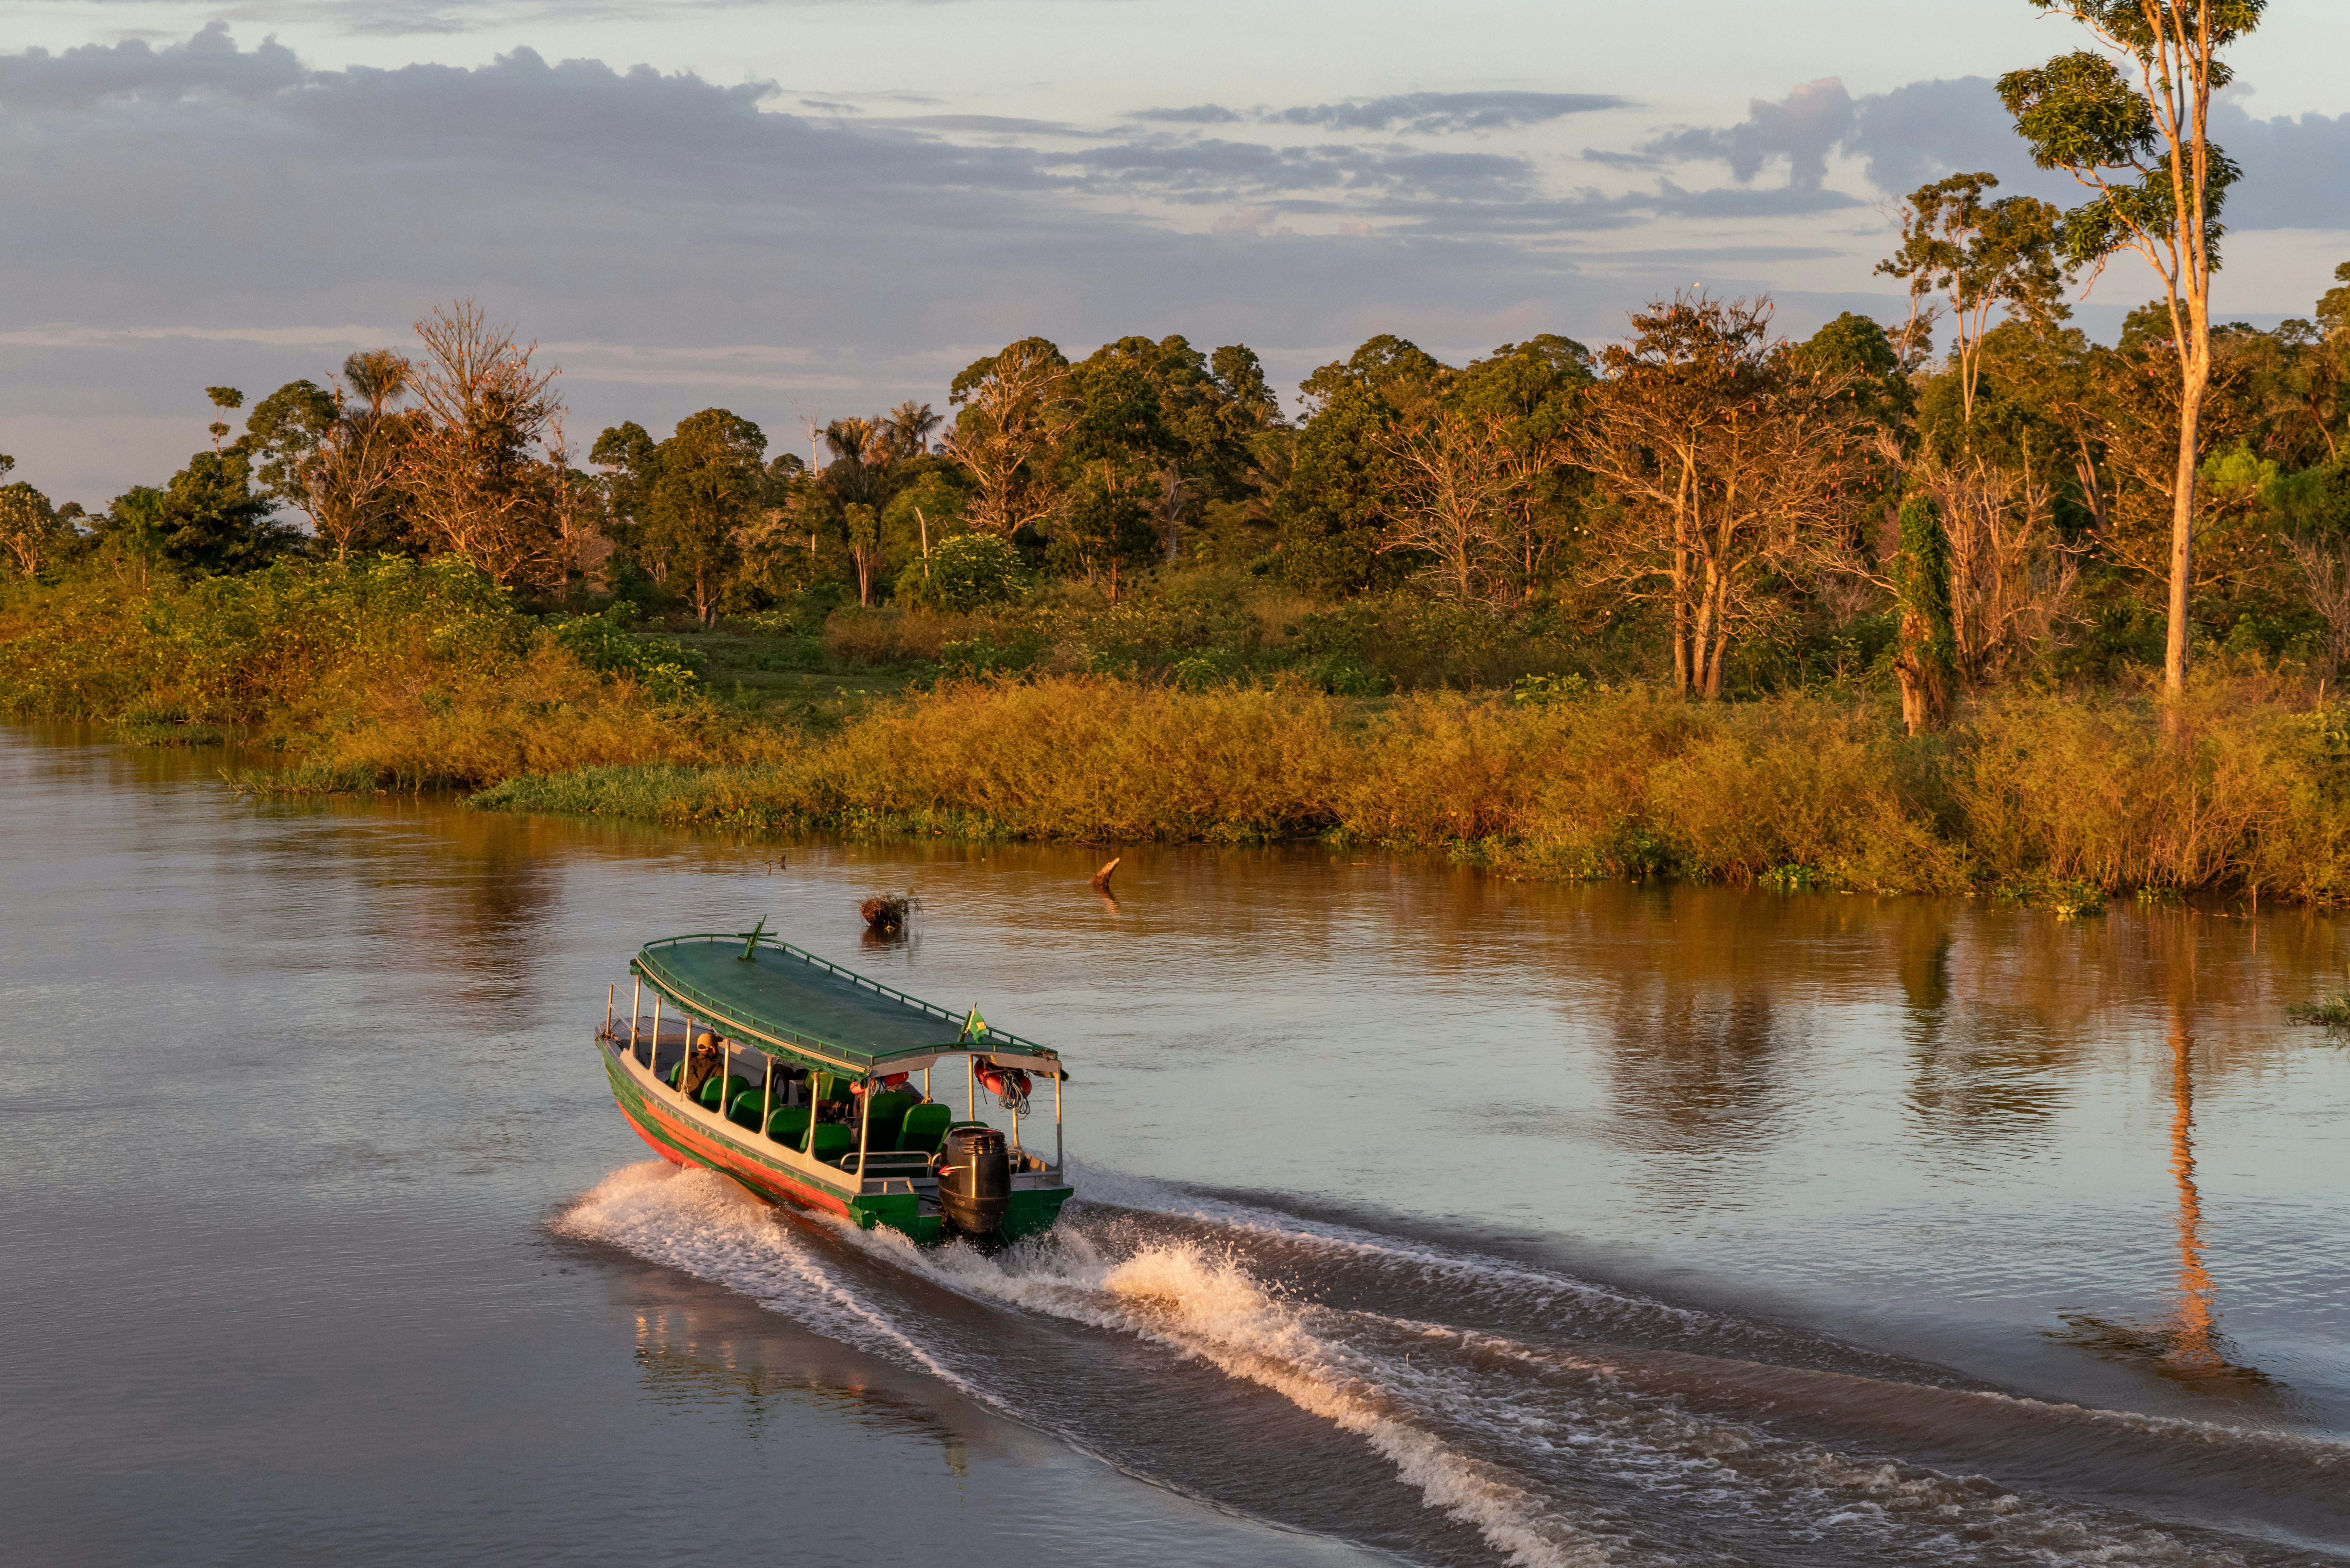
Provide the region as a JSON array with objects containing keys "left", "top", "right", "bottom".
[{"left": 557, "top": 1164, "right": 2350, "bottom": 1568}]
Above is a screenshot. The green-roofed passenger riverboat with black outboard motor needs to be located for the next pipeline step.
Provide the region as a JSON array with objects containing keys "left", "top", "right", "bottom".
[{"left": 597, "top": 919, "right": 1072, "bottom": 1244}]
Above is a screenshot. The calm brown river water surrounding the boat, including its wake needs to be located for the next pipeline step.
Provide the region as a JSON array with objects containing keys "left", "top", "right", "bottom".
[{"left": 0, "top": 731, "right": 2350, "bottom": 1568}]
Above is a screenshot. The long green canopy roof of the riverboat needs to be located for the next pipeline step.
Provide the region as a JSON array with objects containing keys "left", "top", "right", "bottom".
[{"left": 630, "top": 921, "right": 1060, "bottom": 1074}]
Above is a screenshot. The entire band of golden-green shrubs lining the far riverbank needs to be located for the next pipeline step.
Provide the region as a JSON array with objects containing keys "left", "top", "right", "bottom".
[{"left": 14, "top": 562, "right": 2350, "bottom": 907}]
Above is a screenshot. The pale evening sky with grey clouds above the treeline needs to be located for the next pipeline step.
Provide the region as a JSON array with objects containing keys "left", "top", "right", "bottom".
[{"left": 0, "top": 0, "right": 2350, "bottom": 510}]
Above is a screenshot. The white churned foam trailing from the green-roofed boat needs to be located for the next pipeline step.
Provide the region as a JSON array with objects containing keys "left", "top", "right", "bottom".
[{"left": 559, "top": 1161, "right": 2293, "bottom": 1568}]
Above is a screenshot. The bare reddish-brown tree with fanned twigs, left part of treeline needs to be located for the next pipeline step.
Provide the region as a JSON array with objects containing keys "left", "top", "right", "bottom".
[{"left": 399, "top": 301, "right": 569, "bottom": 588}]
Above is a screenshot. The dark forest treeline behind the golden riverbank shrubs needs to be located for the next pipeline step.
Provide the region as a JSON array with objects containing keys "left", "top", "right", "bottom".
[{"left": 14, "top": 235, "right": 2350, "bottom": 727}]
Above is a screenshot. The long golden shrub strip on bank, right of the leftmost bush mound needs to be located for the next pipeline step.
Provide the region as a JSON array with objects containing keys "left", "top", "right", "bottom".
[{"left": 477, "top": 677, "right": 2350, "bottom": 900}]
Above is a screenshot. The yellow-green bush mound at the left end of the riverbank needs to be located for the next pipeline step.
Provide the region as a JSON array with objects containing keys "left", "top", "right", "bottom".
[{"left": 0, "top": 559, "right": 773, "bottom": 792}]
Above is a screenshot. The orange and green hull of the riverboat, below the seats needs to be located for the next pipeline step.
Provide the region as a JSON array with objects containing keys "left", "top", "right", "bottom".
[{"left": 597, "top": 1039, "right": 1072, "bottom": 1244}]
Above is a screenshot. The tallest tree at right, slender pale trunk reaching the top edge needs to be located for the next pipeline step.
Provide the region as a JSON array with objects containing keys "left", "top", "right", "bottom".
[{"left": 2000, "top": 0, "right": 2268, "bottom": 696}]
